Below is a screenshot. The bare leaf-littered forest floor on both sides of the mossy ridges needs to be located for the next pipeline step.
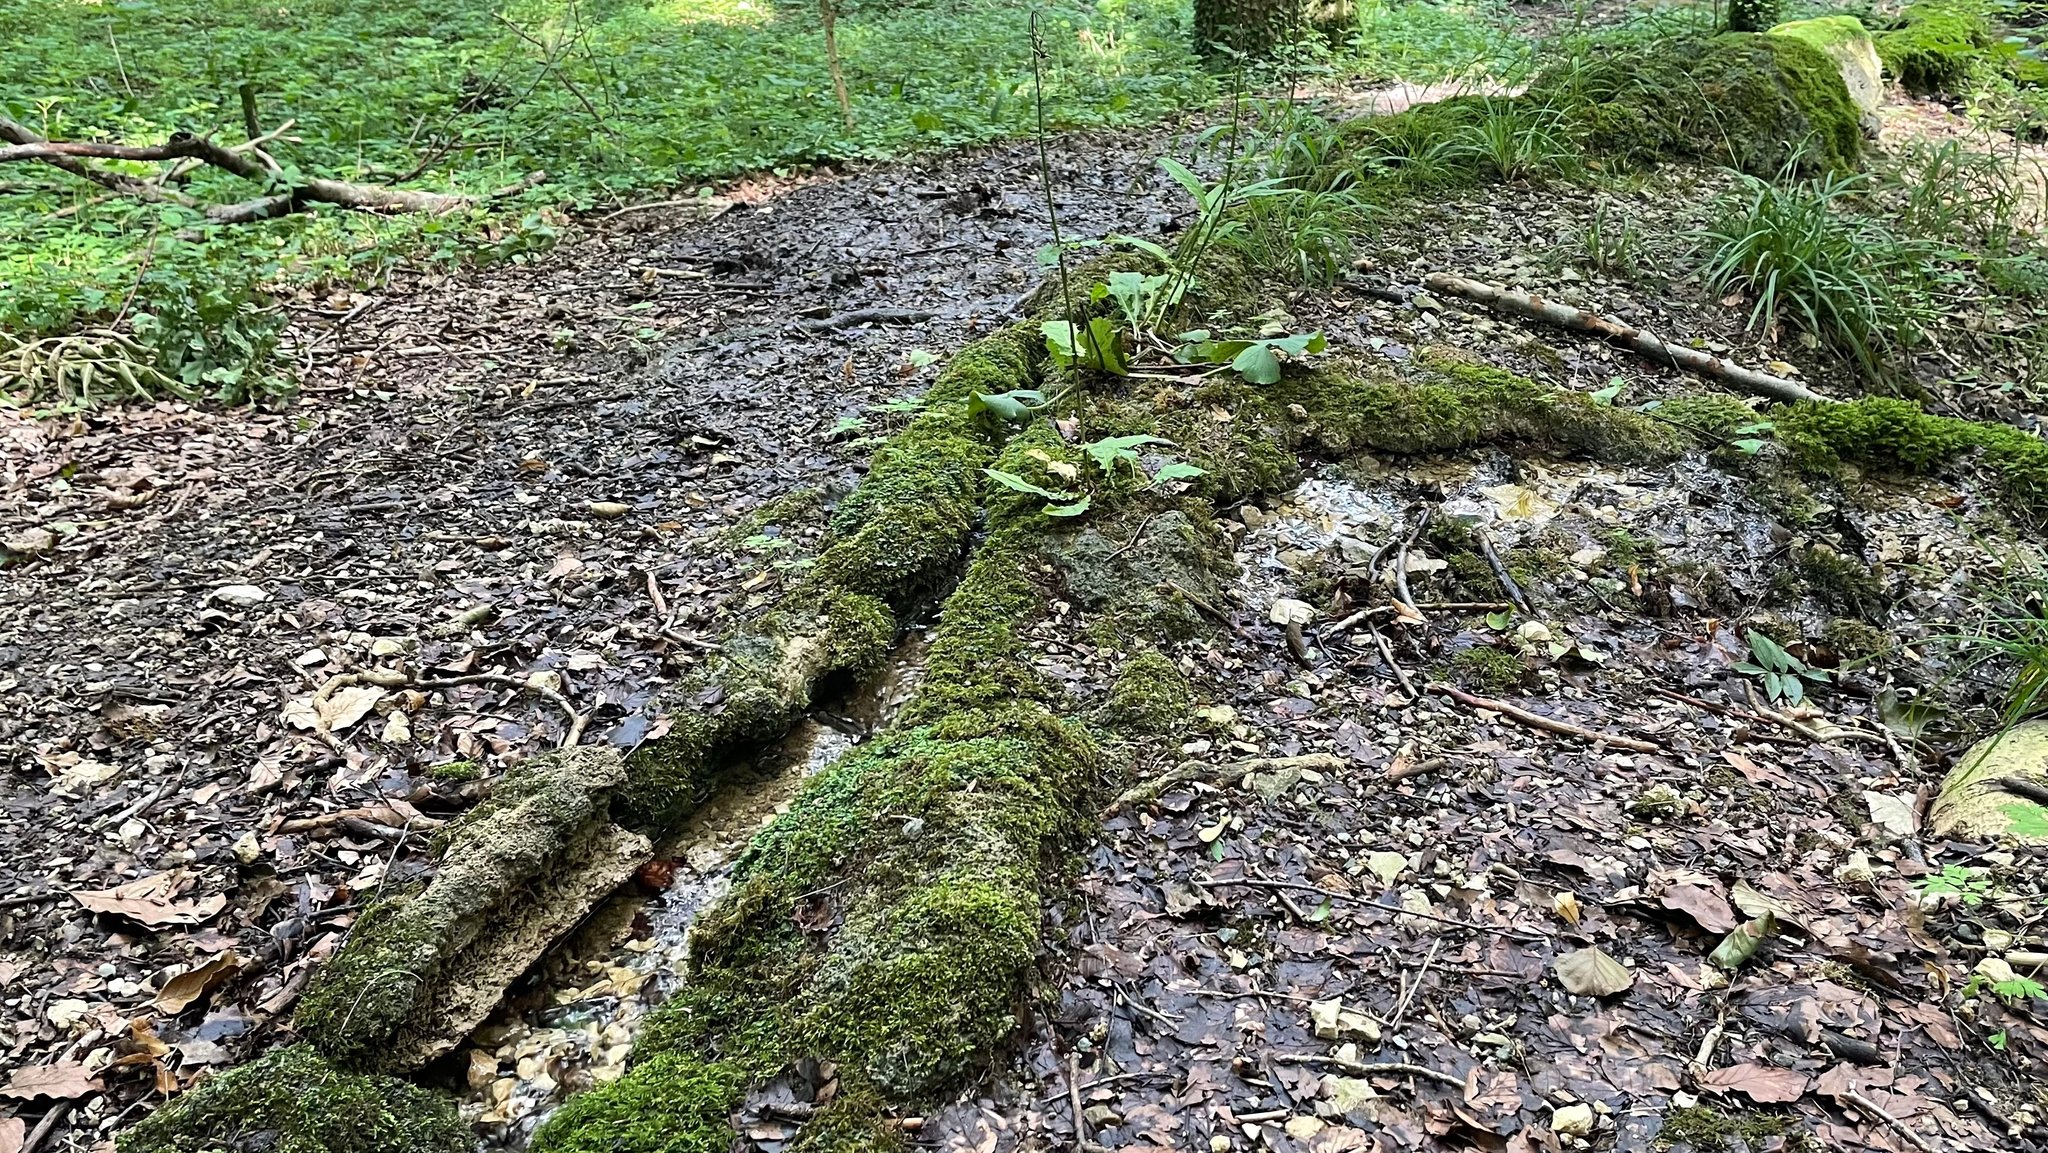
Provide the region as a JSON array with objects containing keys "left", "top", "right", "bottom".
[{"left": 0, "top": 2, "right": 2048, "bottom": 1153}]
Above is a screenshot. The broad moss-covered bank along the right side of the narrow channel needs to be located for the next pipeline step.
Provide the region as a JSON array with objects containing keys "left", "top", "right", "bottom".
[{"left": 535, "top": 426, "right": 1096, "bottom": 1153}]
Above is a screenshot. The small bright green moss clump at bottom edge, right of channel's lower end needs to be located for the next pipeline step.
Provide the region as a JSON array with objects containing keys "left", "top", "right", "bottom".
[{"left": 528, "top": 1055, "right": 748, "bottom": 1153}]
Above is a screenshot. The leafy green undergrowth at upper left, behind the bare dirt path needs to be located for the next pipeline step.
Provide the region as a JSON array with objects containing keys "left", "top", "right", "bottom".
[{"left": 0, "top": 0, "right": 1217, "bottom": 405}]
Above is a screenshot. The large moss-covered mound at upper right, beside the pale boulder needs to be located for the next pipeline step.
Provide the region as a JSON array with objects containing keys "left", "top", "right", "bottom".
[{"left": 1319, "top": 33, "right": 1864, "bottom": 188}]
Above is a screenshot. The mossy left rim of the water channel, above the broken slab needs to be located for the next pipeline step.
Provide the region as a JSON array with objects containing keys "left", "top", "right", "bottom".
[{"left": 618, "top": 326, "right": 1042, "bottom": 827}]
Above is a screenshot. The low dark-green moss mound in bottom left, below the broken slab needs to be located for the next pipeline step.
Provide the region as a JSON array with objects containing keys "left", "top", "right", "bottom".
[{"left": 117, "top": 1044, "right": 475, "bottom": 1153}]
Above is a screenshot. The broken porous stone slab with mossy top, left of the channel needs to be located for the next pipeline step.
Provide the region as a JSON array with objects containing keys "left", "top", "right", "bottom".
[{"left": 295, "top": 748, "right": 653, "bottom": 1071}]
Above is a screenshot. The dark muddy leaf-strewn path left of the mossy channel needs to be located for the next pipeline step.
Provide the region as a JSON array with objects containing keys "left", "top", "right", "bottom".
[{"left": 0, "top": 121, "right": 1180, "bottom": 1130}]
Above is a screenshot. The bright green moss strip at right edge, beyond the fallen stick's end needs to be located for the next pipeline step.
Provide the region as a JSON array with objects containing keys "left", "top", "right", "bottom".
[{"left": 1774, "top": 397, "right": 2048, "bottom": 524}]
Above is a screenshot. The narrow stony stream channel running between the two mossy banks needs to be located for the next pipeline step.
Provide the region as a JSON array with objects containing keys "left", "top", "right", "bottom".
[{"left": 457, "top": 631, "right": 928, "bottom": 1149}]
